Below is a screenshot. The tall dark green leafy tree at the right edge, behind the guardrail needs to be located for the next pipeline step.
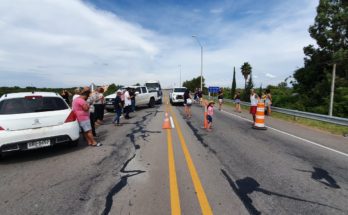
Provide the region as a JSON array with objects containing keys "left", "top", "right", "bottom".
[{"left": 294, "top": 0, "right": 348, "bottom": 116}]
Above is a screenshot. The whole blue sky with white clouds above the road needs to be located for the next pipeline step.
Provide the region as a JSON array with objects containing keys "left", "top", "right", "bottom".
[{"left": 0, "top": 0, "right": 318, "bottom": 88}]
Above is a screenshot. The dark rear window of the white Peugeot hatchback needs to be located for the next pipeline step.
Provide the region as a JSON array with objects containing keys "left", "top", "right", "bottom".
[{"left": 0, "top": 97, "right": 69, "bottom": 114}]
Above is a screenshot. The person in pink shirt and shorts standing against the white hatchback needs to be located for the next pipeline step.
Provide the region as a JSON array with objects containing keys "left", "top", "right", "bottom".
[{"left": 72, "top": 90, "right": 102, "bottom": 146}]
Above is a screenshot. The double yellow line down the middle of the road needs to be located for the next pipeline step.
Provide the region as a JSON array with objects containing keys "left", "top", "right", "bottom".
[{"left": 166, "top": 98, "right": 213, "bottom": 215}]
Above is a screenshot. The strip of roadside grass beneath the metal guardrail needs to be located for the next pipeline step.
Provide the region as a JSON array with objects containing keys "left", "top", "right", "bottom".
[{"left": 205, "top": 100, "right": 348, "bottom": 136}]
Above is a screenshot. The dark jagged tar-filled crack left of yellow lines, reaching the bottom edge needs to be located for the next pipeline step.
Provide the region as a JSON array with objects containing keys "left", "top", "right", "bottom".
[{"left": 102, "top": 154, "right": 146, "bottom": 215}]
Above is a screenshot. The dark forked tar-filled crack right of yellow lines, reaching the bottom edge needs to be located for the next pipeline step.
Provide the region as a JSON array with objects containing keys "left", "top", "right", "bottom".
[{"left": 221, "top": 169, "right": 342, "bottom": 215}]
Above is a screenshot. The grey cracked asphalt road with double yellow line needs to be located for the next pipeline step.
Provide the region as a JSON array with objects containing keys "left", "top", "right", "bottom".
[{"left": 0, "top": 96, "right": 348, "bottom": 215}]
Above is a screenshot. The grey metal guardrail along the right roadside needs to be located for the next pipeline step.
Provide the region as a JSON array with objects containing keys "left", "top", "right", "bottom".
[{"left": 209, "top": 97, "right": 348, "bottom": 126}]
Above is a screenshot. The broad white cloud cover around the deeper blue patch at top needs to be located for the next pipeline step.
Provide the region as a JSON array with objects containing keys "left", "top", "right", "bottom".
[{"left": 0, "top": 0, "right": 315, "bottom": 87}]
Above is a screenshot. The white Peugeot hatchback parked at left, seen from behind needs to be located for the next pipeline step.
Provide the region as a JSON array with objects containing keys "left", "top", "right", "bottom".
[{"left": 0, "top": 92, "right": 80, "bottom": 156}]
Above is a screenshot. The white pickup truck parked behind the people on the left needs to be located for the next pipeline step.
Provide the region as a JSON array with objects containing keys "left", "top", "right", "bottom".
[{"left": 105, "top": 86, "right": 158, "bottom": 111}]
